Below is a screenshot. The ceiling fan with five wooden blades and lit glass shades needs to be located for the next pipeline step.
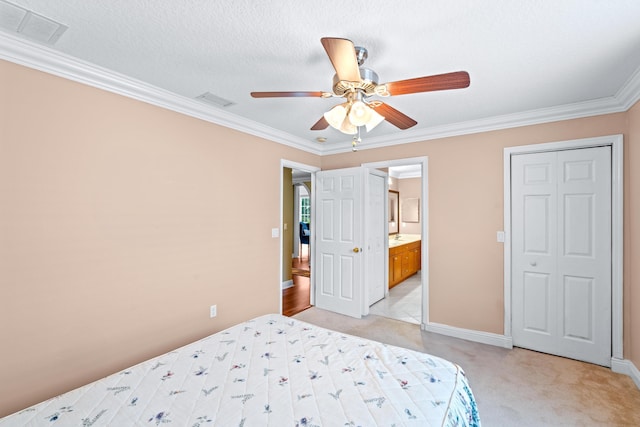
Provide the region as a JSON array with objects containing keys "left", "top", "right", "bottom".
[{"left": 251, "top": 37, "right": 470, "bottom": 149}]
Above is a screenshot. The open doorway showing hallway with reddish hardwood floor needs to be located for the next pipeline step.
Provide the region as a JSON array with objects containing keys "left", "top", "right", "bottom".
[{"left": 281, "top": 160, "right": 319, "bottom": 316}]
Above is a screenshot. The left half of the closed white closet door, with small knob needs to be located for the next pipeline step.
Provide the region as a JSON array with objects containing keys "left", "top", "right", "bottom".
[{"left": 511, "top": 153, "right": 557, "bottom": 353}]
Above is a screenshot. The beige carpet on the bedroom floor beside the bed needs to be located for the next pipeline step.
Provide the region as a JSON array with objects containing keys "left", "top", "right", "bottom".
[{"left": 293, "top": 307, "right": 640, "bottom": 427}]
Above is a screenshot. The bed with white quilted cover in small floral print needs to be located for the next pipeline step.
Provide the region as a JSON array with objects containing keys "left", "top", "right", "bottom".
[{"left": 0, "top": 314, "right": 480, "bottom": 427}]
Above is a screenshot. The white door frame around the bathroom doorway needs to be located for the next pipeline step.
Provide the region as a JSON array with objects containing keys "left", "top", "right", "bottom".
[{"left": 362, "top": 156, "right": 429, "bottom": 330}]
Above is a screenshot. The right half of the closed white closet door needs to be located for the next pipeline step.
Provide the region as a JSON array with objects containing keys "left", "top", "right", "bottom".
[{"left": 558, "top": 147, "right": 611, "bottom": 366}]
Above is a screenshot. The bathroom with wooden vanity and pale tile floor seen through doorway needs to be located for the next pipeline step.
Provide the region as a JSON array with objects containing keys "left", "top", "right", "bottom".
[{"left": 369, "top": 165, "right": 422, "bottom": 324}]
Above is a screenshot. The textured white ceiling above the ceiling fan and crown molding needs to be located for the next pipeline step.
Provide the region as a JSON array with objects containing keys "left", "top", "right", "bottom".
[{"left": 3, "top": 0, "right": 640, "bottom": 154}]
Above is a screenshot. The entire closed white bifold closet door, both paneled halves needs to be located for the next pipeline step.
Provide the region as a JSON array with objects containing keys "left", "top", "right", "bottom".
[{"left": 511, "top": 147, "right": 611, "bottom": 366}]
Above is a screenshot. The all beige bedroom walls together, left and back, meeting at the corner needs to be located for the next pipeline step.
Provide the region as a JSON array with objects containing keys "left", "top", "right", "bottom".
[{"left": 0, "top": 56, "right": 640, "bottom": 416}]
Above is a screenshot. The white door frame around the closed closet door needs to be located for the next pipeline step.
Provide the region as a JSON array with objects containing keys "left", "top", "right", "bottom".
[{"left": 503, "top": 135, "right": 624, "bottom": 367}]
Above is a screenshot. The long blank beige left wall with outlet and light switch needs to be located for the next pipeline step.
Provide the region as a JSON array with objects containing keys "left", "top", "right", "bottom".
[{"left": 0, "top": 61, "right": 320, "bottom": 416}]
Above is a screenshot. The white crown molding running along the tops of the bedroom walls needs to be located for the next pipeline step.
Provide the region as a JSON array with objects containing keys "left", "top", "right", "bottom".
[{"left": 0, "top": 31, "right": 640, "bottom": 156}]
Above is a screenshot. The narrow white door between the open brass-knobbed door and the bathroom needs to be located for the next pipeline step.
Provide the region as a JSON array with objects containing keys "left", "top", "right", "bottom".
[{"left": 364, "top": 170, "right": 389, "bottom": 306}]
